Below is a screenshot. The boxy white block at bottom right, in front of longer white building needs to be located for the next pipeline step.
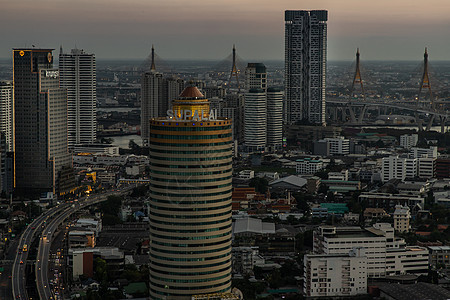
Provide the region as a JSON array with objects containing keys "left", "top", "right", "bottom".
[{"left": 303, "top": 248, "right": 367, "bottom": 297}]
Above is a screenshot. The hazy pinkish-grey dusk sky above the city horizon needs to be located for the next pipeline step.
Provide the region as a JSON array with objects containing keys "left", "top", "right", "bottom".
[{"left": 0, "top": 0, "right": 450, "bottom": 61}]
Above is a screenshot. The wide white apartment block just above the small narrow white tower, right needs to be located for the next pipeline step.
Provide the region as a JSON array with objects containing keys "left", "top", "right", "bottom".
[{"left": 381, "top": 155, "right": 417, "bottom": 182}]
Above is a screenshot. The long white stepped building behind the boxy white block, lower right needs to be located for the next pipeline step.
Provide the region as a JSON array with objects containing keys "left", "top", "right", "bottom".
[{"left": 314, "top": 223, "right": 428, "bottom": 277}]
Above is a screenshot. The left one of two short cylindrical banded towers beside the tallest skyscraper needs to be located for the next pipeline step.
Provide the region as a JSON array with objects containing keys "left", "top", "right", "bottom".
[{"left": 244, "top": 89, "right": 267, "bottom": 151}]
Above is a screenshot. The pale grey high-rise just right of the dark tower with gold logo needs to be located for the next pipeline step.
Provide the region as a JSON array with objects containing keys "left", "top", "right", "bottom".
[{"left": 59, "top": 47, "right": 97, "bottom": 149}]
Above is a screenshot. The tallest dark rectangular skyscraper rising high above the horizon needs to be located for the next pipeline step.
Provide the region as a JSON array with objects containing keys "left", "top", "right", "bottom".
[{"left": 284, "top": 10, "right": 328, "bottom": 125}]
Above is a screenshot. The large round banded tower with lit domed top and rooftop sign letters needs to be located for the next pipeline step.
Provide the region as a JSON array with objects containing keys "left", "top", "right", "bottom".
[{"left": 149, "top": 86, "right": 232, "bottom": 300}]
